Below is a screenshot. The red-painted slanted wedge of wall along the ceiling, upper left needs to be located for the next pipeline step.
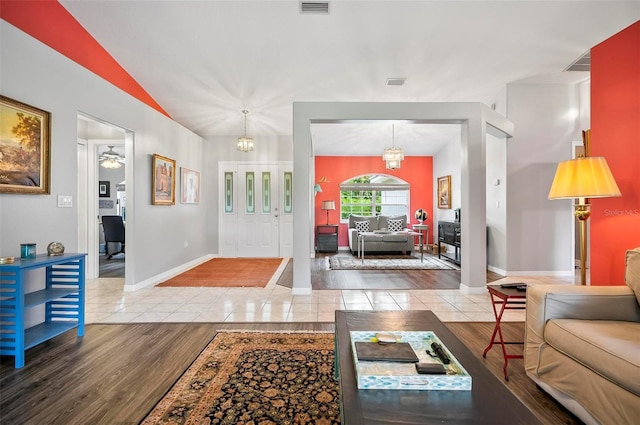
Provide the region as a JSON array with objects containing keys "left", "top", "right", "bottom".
[{"left": 0, "top": 0, "right": 171, "bottom": 118}]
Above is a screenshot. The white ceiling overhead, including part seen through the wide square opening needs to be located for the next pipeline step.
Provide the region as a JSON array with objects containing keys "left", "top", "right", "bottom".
[{"left": 61, "top": 0, "right": 640, "bottom": 155}]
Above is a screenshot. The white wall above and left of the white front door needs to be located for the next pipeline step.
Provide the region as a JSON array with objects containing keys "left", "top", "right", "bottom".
[{"left": 203, "top": 134, "right": 295, "bottom": 254}]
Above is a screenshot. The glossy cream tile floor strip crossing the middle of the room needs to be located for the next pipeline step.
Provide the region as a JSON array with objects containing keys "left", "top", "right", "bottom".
[{"left": 86, "top": 276, "right": 574, "bottom": 323}]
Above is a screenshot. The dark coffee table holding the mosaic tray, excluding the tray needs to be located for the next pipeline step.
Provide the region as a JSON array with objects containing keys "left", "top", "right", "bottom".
[{"left": 336, "top": 310, "right": 541, "bottom": 425}]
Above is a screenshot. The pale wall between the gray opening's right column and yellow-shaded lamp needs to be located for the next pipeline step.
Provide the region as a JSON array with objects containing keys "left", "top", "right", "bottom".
[{"left": 507, "top": 83, "right": 584, "bottom": 274}]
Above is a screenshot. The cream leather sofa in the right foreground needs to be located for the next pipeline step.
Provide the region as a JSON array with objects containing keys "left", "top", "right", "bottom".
[{"left": 524, "top": 248, "right": 640, "bottom": 425}]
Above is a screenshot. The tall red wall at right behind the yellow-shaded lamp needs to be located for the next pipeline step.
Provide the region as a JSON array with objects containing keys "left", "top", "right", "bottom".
[{"left": 590, "top": 21, "right": 640, "bottom": 285}]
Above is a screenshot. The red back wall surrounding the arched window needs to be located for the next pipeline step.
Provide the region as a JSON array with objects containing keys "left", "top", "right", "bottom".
[{"left": 315, "top": 156, "right": 433, "bottom": 246}]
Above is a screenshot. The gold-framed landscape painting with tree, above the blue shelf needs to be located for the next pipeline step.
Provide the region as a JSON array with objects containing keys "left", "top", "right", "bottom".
[{"left": 0, "top": 95, "right": 51, "bottom": 194}]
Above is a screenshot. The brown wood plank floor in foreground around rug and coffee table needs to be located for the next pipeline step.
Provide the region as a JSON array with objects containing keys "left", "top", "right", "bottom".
[{"left": 0, "top": 322, "right": 580, "bottom": 425}]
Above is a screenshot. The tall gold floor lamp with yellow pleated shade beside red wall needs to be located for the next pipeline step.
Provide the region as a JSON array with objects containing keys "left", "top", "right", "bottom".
[{"left": 549, "top": 157, "right": 621, "bottom": 285}]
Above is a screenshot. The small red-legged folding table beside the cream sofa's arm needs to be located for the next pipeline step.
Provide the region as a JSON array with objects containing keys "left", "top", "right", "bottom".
[{"left": 482, "top": 283, "right": 527, "bottom": 381}]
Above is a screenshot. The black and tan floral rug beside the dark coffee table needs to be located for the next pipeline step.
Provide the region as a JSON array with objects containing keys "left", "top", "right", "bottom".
[{"left": 142, "top": 331, "right": 340, "bottom": 425}]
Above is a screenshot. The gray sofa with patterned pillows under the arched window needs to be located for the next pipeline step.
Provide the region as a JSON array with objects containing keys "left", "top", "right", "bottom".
[{"left": 348, "top": 215, "right": 414, "bottom": 254}]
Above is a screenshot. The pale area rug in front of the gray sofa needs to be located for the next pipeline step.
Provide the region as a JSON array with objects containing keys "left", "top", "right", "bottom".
[{"left": 326, "top": 255, "right": 456, "bottom": 270}]
